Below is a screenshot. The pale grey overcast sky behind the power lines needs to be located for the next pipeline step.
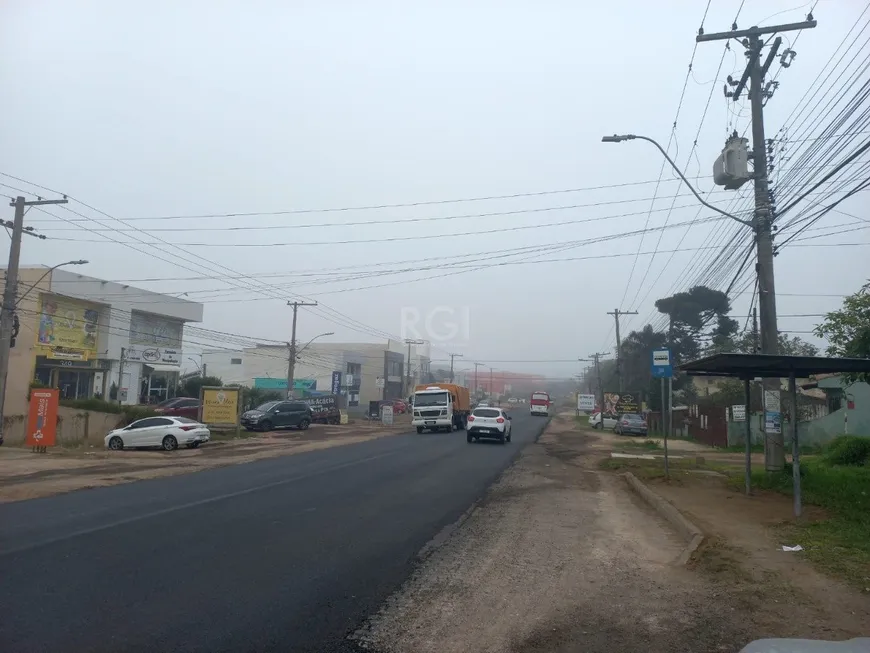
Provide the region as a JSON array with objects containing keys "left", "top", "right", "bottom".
[{"left": 0, "top": 0, "right": 870, "bottom": 376}]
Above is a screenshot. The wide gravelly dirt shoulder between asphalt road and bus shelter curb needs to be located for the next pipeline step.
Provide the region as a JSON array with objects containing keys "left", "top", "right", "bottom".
[{"left": 355, "top": 416, "right": 767, "bottom": 653}]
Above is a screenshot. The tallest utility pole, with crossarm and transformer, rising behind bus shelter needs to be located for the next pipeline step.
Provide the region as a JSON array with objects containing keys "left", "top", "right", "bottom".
[{"left": 695, "top": 13, "right": 817, "bottom": 471}]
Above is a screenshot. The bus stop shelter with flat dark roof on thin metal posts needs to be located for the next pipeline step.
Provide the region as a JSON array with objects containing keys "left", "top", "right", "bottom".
[{"left": 678, "top": 354, "right": 870, "bottom": 517}]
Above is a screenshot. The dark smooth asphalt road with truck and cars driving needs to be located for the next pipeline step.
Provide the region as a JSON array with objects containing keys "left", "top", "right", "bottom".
[{"left": 0, "top": 409, "right": 545, "bottom": 653}]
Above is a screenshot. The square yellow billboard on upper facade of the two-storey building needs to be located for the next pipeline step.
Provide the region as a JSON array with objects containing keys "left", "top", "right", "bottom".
[{"left": 36, "top": 295, "right": 100, "bottom": 360}]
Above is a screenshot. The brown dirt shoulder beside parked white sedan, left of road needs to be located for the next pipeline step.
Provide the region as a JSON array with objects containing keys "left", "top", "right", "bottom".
[{"left": 0, "top": 424, "right": 408, "bottom": 503}]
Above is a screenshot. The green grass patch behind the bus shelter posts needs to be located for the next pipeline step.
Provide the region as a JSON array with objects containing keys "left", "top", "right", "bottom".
[{"left": 735, "top": 456, "right": 870, "bottom": 590}]
